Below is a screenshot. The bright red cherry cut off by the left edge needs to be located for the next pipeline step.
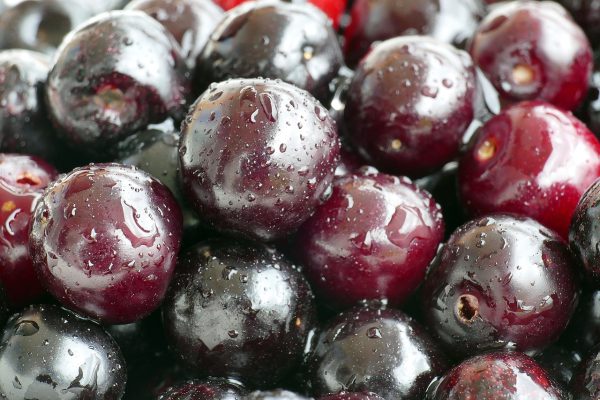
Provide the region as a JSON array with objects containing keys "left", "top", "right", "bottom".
[{"left": 0, "top": 153, "right": 58, "bottom": 306}]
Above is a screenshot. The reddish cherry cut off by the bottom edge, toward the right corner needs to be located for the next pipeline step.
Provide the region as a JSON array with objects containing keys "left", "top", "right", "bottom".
[{"left": 425, "top": 352, "right": 569, "bottom": 400}]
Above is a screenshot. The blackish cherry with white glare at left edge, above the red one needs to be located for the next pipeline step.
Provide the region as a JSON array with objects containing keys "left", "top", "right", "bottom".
[{"left": 0, "top": 50, "right": 78, "bottom": 170}]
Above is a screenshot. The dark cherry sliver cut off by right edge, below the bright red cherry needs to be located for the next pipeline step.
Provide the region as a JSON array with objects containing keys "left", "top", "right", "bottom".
[{"left": 569, "top": 180, "right": 600, "bottom": 284}]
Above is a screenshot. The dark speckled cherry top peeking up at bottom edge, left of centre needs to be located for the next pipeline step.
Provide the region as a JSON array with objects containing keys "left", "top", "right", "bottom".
[{"left": 158, "top": 378, "right": 245, "bottom": 400}]
